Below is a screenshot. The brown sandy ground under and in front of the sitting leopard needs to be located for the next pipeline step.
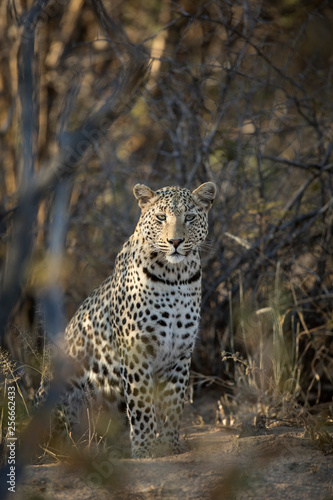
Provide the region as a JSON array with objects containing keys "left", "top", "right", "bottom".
[{"left": 13, "top": 394, "right": 333, "bottom": 500}]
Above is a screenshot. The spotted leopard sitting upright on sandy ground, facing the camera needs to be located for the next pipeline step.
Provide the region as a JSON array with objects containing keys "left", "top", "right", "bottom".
[{"left": 35, "top": 182, "right": 216, "bottom": 459}]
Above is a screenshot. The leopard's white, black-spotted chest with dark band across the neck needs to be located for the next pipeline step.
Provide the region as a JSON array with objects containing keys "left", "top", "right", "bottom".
[{"left": 121, "top": 266, "right": 201, "bottom": 370}]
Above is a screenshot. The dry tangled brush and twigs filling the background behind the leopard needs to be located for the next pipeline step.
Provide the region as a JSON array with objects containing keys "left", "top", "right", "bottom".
[{"left": 0, "top": 0, "right": 333, "bottom": 484}]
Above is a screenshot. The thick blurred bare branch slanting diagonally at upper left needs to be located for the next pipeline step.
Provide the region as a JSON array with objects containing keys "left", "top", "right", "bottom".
[{"left": 0, "top": 2, "right": 149, "bottom": 337}]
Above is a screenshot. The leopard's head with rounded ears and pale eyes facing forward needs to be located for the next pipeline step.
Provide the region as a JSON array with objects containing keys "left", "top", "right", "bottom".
[{"left": 133, "top": 182, "right": 216, "bottom": 264}]
